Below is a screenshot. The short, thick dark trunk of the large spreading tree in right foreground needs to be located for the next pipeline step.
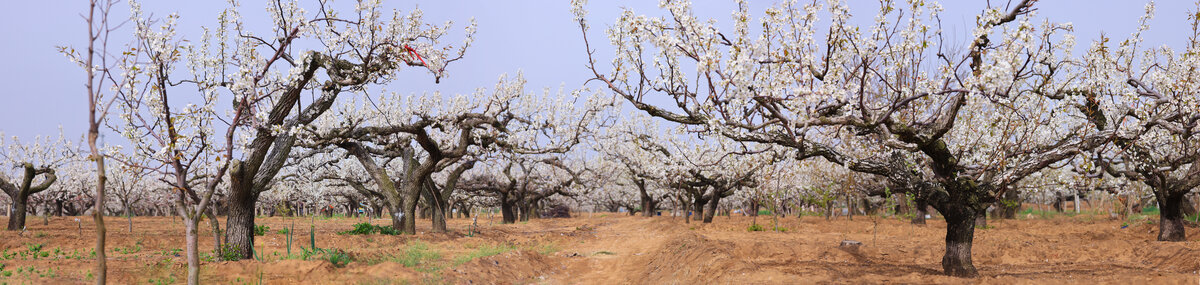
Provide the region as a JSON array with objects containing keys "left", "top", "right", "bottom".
[{"left": 942, "top": 205, "right": 979, "bottom": 277}]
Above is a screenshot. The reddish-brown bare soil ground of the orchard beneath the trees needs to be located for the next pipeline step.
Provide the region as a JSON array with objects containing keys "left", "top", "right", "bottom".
[{"left": 0, "top": 213, "right": 1200, "bottom": 284}]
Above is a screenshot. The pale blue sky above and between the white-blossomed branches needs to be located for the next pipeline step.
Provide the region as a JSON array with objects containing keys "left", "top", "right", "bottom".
[{"left": 0, "top": 0, "right": 1195, "bottom": 140}]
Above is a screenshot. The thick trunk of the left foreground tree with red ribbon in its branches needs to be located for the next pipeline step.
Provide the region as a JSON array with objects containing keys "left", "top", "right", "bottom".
[{"left": 226, "top": 163, "right": 258, "bottom": 259}]
